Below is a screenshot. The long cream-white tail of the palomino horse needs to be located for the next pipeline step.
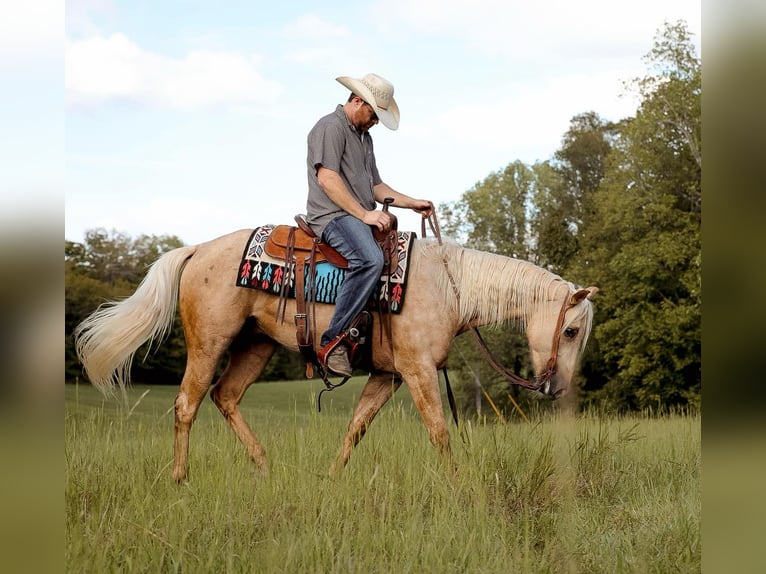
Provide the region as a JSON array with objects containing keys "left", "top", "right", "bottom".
[{"left": 74, "top": 246, "right": 197, "bottom": 394}]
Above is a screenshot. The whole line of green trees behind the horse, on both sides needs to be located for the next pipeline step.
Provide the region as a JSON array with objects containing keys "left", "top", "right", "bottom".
[{"left": 65, "top": 22, "right": 702, "bottom": 414}]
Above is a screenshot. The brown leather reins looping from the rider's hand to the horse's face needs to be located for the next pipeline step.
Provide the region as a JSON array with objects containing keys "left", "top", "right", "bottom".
[{"left": 421, "top": 209, "right": 579, "bottom": 396}]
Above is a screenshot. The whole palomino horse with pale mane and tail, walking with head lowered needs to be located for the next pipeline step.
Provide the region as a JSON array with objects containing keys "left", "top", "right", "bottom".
[{"left": 75, "top": 230, "right": 597, "bottom": 482}]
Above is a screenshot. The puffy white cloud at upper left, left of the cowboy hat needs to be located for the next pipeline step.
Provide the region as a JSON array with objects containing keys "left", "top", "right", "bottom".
[{"left": 66, "top": 34, "right": 282, "bottom": 110}]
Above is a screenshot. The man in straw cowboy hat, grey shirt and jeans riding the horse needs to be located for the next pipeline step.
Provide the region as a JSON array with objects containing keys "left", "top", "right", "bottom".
[{"left": 306, "top": 74, "right": 433, "bottom": 377}]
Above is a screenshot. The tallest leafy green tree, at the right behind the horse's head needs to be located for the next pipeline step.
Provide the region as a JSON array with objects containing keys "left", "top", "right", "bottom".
[{"left": 568, "top": 23, "right": 702, "bottom": 409}]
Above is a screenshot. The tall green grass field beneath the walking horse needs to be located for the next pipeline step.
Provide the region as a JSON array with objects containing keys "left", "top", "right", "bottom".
[{"left": 65, "top": 379, "right": 702, "bottom": 573}]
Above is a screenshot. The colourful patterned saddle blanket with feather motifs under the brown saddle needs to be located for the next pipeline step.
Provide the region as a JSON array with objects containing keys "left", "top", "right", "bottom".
[{"left": 237, "top": 225, "right": 416, "bottom": 313}]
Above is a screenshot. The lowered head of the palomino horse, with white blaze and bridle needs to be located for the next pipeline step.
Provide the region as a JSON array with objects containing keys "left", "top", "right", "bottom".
[{"left": 527, "top": 284, "right": 598, "bottom": 399}]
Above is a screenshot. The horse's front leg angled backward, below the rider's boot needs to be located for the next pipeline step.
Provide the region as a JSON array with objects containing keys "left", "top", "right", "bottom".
[{"left": 330, "top": 373, "right": 402, "bottom": 476}]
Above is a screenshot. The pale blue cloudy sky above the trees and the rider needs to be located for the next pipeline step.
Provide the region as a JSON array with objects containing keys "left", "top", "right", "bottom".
[{"left": 60, "top": 0, "right": 701, "bottom": 244}]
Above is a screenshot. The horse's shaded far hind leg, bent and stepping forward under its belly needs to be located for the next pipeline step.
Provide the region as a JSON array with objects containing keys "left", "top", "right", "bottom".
[{"left": 210, "top": 337, "right": 277, "bottom": 474}]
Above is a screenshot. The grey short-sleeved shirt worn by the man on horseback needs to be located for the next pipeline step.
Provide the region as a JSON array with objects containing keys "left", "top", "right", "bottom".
[{"left": 306, "top": 104, "right": 382, "bottom": 237}]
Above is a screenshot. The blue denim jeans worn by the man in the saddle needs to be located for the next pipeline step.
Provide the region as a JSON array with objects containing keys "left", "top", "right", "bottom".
[{"left": 321, "top": 215, "right": 383, "bottom": 347}]
